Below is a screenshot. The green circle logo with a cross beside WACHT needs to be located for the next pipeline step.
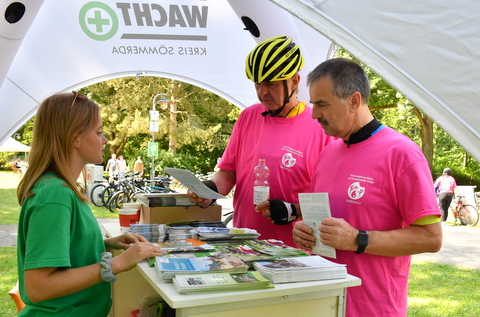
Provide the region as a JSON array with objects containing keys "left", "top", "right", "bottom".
[{"left": 78, "top": 1, "right": 118, "bottom": 41}]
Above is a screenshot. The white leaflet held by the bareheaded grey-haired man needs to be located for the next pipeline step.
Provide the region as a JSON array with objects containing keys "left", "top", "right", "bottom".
[{"left": 298, "top": 193, "right": 337, "bottom": 259}]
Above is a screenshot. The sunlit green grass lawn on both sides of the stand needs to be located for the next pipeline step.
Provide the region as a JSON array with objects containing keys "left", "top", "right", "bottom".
[{"left": 0, "top": 172, "right": 480, "bottom": 317}]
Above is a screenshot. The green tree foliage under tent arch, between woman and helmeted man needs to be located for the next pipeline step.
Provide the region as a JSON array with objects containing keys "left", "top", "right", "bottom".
[{"left": 81, "top": 77, "right": 239, "bottom": 173}]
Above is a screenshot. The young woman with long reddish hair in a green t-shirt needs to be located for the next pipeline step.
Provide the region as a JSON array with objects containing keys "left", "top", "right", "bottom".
[{"left": 17, "top": 92, "right": 164, "bottom": 316}]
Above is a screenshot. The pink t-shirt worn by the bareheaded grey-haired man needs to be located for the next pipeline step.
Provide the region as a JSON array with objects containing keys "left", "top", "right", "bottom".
[{"left": 312, "top": 127, "right": 440, "bottom": 317}]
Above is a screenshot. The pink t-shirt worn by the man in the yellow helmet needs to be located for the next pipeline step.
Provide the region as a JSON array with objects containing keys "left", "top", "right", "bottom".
[{"left": 218, "top": 104, "right": 332, "bottom": 246}]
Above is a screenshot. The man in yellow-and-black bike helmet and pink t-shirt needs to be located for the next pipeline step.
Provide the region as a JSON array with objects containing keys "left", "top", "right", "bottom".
[{"left": 189, "top": 36, "right": 332, "bottom": 246}]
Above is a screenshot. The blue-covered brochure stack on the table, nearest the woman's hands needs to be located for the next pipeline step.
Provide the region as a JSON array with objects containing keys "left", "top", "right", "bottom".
[{"left": 155, "top": 254, "right": 248, "bottom": 282}]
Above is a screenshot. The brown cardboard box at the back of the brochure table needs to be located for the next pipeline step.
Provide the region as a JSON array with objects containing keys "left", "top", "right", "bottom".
[{"left": 140, "top": 204, "right": 222, "bottom": 224}]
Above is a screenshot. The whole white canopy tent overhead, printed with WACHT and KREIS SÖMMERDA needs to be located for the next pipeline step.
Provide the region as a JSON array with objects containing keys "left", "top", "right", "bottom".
[{"left": 0, "top": 0, "right": 480, "bottom": 161}]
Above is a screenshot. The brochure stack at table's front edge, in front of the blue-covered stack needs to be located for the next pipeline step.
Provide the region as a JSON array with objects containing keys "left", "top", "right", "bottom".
[{"left": 173, "top": 271, "right": 273, "bottom": 294}]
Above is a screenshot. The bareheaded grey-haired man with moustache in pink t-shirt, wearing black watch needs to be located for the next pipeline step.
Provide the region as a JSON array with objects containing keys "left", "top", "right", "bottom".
[{"left": 288, "top": 58, "right": 442, "bottom": 317}]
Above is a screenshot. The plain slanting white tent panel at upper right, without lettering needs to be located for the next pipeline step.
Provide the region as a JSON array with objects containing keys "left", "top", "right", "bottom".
[{"left": 272, "top": 0, "right": 480, "bottom": 162}]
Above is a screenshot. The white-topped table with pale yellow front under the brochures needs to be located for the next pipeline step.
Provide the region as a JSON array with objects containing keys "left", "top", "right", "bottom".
[{"left": 102, "top": 223, "right": 361, "bottom": 317}]
